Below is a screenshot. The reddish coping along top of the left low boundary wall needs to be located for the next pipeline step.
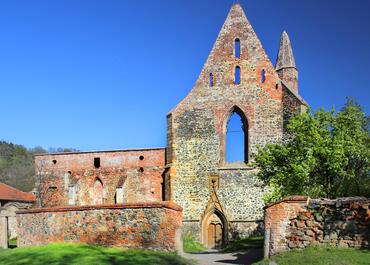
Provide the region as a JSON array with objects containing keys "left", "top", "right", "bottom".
[{"left": 16, "top": 201, "right": 182, "bottom": 214}]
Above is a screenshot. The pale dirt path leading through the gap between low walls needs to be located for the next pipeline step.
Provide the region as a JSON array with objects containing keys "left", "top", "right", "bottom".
[{"left": 183, "top": 246, "right": 263, "bottom": 265}]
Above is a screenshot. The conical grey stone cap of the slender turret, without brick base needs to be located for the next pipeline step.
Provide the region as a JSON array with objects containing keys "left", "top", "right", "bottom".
[{"left": 275, "top": 30, "right": 297, "bottom": 71}]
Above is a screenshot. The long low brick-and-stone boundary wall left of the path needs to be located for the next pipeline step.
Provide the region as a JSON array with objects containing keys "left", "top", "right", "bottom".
[{"left": 17, "top": 202, "right": 182, "bottom": 251}]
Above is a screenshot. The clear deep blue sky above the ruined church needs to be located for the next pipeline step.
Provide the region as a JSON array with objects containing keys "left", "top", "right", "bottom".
[{"left": 0, "top": 0, "right": 370, "bottom": 150}]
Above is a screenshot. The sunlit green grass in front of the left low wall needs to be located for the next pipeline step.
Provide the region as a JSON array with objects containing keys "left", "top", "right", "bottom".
[{"left": 0, "top": 243, "right": 192, "bottom": 265}]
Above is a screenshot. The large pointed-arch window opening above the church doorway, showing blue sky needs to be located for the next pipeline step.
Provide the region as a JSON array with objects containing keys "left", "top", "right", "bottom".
[{"left": 225, "top": 107, "right": 249, "bottom": 163}]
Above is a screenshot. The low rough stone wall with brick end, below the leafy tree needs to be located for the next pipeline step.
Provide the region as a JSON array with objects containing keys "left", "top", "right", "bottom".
[{"left": 265, "top": 196, "right": 370, "bottom": 257}]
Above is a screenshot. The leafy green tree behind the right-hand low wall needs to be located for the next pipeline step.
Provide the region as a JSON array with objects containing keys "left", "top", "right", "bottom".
[{"left": 255, "top": 99, "right": 370, "bottom": 201}]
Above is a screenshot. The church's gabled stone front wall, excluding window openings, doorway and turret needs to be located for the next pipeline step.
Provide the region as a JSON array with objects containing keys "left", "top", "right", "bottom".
[{"left": 167, "top": 4, "right": 302, "bottom": 238}]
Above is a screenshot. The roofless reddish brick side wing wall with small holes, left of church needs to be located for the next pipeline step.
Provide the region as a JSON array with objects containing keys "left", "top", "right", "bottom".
[{"left": 35, "top": 148, "right": 165, "bottom": 207}]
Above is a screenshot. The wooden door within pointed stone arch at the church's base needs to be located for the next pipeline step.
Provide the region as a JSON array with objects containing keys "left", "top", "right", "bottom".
[{"left": 202, "top": 208, "right": 228, "bottom": 248}]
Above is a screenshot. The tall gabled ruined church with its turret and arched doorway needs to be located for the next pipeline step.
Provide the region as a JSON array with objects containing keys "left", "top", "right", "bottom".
[{"left": 164, "top": 4, "right": 307, "bottom": 247}]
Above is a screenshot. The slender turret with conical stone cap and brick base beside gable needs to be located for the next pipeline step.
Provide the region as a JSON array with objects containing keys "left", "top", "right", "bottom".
[{"left": 275, "top": 31, "right": 298, "bottom": 94}]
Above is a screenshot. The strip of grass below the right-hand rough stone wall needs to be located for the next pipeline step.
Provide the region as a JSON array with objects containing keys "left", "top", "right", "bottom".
[{"left": 253, "top": 244, "right": 370, "bottom": 265}]
